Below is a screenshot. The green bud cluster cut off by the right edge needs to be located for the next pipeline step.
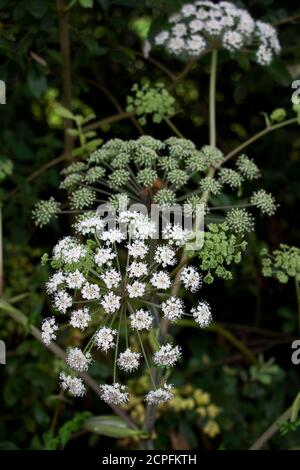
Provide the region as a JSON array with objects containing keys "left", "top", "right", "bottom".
[{"left": 261, "top": 244, "right": 300, "bottom": 284}]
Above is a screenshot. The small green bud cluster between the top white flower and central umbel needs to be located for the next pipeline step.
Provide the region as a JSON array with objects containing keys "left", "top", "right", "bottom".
[{"left": 126, "top": 82, "right": 175, "bottom": 125}]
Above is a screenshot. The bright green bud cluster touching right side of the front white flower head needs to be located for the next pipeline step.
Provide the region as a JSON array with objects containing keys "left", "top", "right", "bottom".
[{"left": 193, "top": 223, "right": 247, "bottom": 284}]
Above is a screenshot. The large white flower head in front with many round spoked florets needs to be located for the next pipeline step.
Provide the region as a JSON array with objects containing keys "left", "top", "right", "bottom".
[{"left": 42, "top": 211, "right": 211, "bottom": 405}]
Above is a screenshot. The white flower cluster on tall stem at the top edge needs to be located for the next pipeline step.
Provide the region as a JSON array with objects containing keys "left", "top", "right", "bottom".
[{"left": 154, "top": 0, "right": 280, "bottom": 65}]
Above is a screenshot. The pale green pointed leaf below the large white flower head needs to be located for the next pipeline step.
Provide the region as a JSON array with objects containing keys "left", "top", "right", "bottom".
[{"left": 83, "top": 416, "right": 147, "bottom": 439}]
